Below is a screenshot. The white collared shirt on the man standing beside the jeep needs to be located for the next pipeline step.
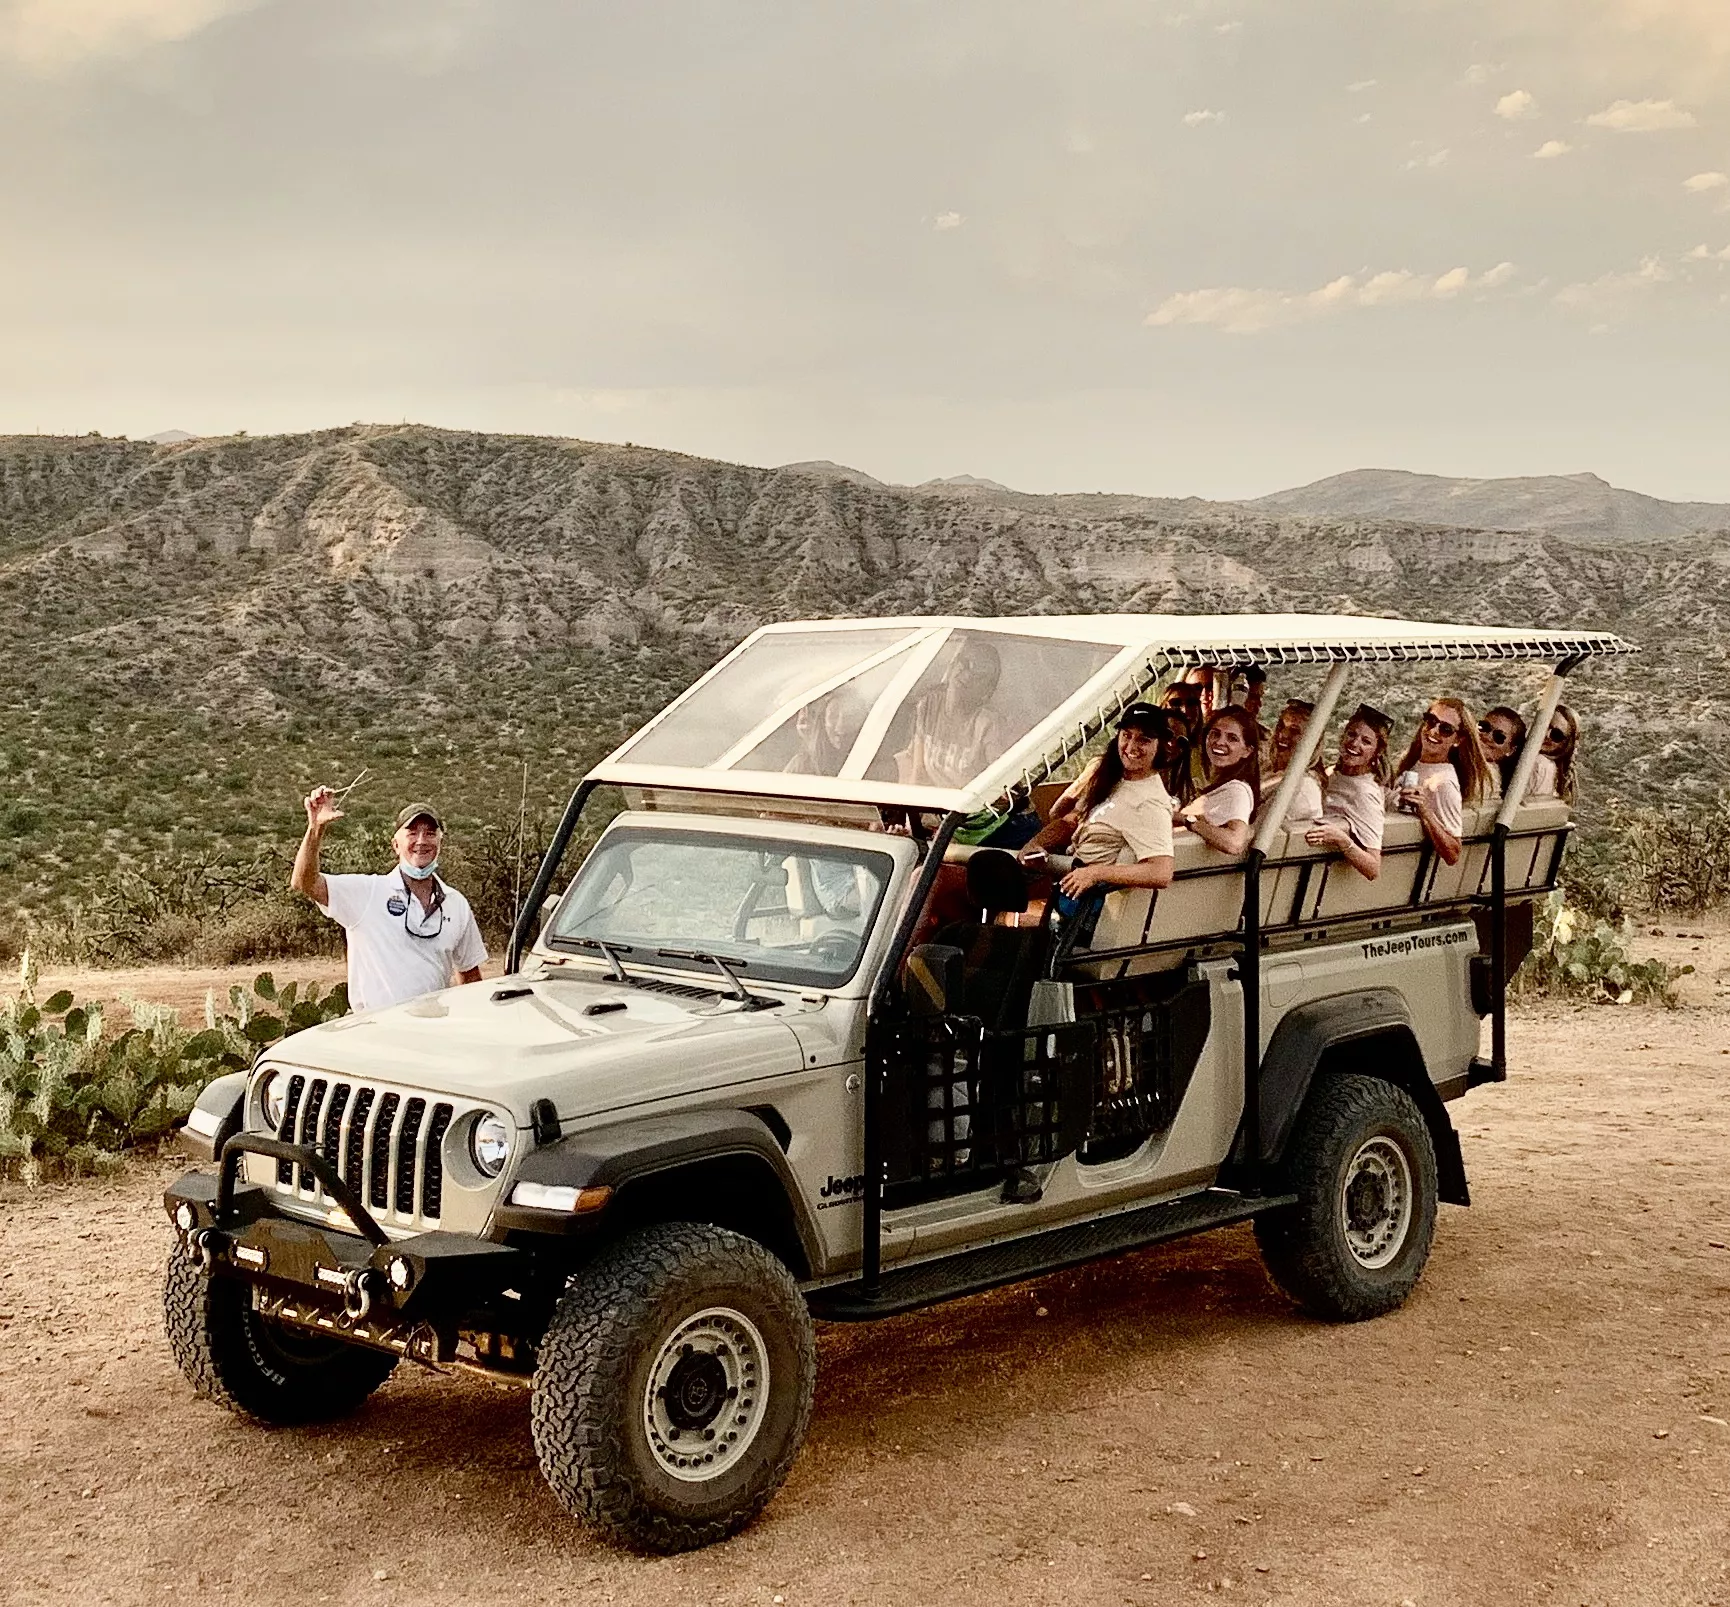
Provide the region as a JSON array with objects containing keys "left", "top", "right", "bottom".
[{"left": 320, "top": 870, "right": 486, "bottom": 1010}]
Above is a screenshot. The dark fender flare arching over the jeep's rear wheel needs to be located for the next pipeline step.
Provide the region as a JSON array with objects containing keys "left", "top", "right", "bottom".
[{"left": 1259, "top": 988, "right": 1471, "bottom": 1206}]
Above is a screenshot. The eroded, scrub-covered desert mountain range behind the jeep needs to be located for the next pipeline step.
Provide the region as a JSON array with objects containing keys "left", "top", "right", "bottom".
[{"left": 0, "top": 426, "right": 1730, "bottom": 908}]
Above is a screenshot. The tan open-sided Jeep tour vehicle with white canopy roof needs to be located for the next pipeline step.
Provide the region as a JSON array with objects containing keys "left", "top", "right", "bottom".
[{"left": 164, "top": 616, "right": 1631, "bottom": 1550}]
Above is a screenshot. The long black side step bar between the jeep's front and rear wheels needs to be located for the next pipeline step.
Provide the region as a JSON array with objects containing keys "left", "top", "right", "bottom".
[{"left": 806, "top": 1188, "right": 1298, "bottom": 1322}]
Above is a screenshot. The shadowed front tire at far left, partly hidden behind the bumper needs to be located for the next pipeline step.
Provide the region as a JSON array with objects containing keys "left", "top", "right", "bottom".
[{"left": 163, "top": 1245, "right": 396, "bottom": 1425}]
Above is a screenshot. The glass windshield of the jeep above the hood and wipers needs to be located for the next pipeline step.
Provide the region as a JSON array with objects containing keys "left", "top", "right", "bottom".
[{"left": 547, "top": 827, "right": 894, "bottom": 988}]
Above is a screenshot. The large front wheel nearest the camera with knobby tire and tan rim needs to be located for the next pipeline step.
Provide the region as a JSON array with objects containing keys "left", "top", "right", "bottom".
[{"left": 531, "top": 1221, "right": 817, "bottom": 1552}]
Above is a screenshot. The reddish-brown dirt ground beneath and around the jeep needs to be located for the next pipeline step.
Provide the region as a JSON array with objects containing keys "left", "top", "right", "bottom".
[{"left": 0, "top": 968, "right": 1730, "bottom": 1607}]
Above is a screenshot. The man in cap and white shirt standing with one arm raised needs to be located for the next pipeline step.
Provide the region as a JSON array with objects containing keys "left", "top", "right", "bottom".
[{"left": 289, "top": 787, "right": 486, "bottom": 1010}]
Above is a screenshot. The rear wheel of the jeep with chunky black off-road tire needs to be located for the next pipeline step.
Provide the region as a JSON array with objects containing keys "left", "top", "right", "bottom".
[{"left": 1256, "top": 1076, "right": 1436, "bottom": 1322}]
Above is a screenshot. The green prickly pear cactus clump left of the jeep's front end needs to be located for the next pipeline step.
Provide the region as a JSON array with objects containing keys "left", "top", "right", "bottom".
[{"left": 0, "top": 953, "right": 348, "bottom": 1183}]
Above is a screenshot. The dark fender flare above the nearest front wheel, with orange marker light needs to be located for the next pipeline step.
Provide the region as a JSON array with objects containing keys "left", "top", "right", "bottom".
[{"left": 488, "top": 1109, "right": 823, "bottom": 1275}]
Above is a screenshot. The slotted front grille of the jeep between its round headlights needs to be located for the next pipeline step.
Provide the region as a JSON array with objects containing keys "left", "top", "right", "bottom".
[{"left": 275, "top": 1071, "right": 474, "bottom": 1226}]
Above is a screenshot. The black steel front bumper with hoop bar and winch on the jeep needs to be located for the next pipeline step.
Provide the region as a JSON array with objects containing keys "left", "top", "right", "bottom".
[{"left": 163, "top": 1133, "right": 535, "bottom": 1367}]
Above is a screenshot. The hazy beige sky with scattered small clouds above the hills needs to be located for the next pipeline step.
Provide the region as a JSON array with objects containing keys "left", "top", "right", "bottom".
[{"left": 0, "top": 0, "right": 1730, "bottom": 502}]
